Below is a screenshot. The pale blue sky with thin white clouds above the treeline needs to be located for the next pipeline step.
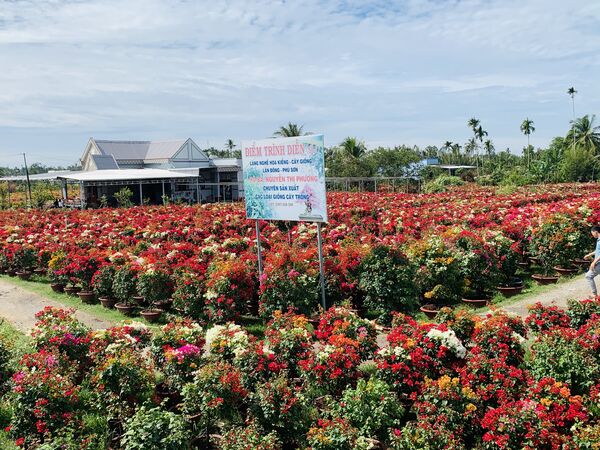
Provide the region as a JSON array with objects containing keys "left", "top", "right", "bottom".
[{"left": 0, "top": 0, "right": 600, "bottom": 165}]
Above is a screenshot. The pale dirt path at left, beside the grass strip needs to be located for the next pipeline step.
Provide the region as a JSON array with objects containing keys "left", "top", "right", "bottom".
[{"left": 0, "top": 280, "right": 114, "bottom": 333}]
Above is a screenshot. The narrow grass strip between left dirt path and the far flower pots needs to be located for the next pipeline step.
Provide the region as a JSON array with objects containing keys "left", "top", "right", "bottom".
[{"left": 0, "top": 275, "right": 160, "bottom": 329}]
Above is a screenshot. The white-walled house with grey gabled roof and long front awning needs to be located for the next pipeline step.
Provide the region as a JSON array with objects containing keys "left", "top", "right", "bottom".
[{"left": 76, "top": 138, "right": 243, "bottom": 204}]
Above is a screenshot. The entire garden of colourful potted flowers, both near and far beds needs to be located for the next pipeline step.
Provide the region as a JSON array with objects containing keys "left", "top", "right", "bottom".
[{"left": 0, "top": 185, "right": 600, "bottom": 450}]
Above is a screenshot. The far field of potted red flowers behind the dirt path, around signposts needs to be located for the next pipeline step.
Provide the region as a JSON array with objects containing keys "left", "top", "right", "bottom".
[{"left": 0, "top": 185, "right": 600, "bottom": 323}]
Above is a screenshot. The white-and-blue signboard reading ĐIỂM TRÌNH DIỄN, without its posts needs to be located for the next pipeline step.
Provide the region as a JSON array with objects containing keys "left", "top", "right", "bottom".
[{"left": 242, "top": 135, "right": 327, "bottom": 222}]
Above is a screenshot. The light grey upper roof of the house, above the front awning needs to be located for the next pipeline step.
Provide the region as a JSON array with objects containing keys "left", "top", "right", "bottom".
[{"left": 94, "top": 140, "right": 186, "bottom": 161}]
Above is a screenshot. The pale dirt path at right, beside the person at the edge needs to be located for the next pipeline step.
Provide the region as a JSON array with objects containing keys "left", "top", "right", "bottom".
[{"left": 488, "top": 274, "right": 591, "bottom": 317}]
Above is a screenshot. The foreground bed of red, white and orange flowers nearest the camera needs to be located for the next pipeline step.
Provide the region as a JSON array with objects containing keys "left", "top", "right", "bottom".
[{"left": 0, "top": 299, "right": 600, "bottom": 450}]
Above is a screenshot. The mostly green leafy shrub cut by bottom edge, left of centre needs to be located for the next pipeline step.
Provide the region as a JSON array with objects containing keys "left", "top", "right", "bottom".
[{"left": 121, "top": 406, "right": 190, "bottom": 450}]
